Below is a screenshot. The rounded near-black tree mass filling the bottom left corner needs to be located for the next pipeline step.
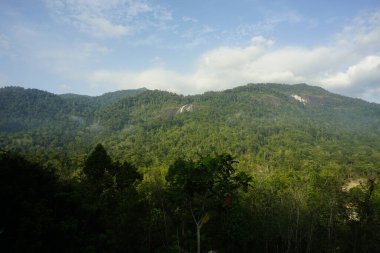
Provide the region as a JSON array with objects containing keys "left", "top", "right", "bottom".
[{"left": 0, "top": 151, "right": 97, "bottom": 252}]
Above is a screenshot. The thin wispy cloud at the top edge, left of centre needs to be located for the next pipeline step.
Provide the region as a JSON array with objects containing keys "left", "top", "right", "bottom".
[{"left": 45, "top": 0, "right": 172, "bottom": 37}]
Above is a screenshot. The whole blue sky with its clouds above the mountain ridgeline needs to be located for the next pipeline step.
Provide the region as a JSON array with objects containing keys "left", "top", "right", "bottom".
[{"left": 0, "top": 0, "right": 380, "bottom": 103}]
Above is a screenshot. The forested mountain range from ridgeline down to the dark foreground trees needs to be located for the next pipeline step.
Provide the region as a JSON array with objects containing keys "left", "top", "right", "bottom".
[{"left": 0, "top": 84, "right": 380, "bottom": 176}]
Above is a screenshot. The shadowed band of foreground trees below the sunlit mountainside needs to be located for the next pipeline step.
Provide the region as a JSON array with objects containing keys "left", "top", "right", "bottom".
[{"left": 0, "top": 142, "right": 380, "bottom": 252}]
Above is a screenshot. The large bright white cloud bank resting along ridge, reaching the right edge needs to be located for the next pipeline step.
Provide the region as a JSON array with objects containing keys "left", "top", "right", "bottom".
[{"left": 89, "top": 11, "right": 380, "bottom": 102}]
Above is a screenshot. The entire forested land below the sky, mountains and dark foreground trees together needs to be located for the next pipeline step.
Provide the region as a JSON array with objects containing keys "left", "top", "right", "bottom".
[{"left": 0, "top": 84, "right": 380, "bottom": 253}]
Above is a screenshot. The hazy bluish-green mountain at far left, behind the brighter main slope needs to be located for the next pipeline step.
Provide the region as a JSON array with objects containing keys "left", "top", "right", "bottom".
[{"left": 0, "top": 87, "right": 145, "bottom": 133}]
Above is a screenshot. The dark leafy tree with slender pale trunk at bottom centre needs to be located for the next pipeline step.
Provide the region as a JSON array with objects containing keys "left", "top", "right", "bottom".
[{"left": 166, "top": 154, "right": 251, "bottom": 253}]
